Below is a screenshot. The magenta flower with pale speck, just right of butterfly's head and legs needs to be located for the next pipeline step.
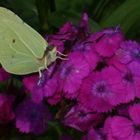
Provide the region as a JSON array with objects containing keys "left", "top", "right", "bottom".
[{"left": 56, "top": 52, "right": 89, "bottom": 98}]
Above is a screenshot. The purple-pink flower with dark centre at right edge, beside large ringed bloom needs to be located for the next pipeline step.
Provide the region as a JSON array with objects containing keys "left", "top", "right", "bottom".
[{"left": 109, "top": 58, "right": 140, "bottom": 100}]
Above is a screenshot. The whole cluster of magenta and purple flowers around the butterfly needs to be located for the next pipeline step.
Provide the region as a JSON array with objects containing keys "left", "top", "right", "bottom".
[{"left": 0, "top": 14, "right": 140, "bottom": 140}]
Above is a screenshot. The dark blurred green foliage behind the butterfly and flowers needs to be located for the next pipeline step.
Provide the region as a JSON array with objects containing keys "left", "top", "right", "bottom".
[{"left": 0, "top": 0, "right": 140, "bottom": 140}]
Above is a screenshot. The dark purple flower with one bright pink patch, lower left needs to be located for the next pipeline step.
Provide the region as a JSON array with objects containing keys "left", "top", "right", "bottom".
[{"left": 16, "top": 99, "right": 51, "bottom": 135}]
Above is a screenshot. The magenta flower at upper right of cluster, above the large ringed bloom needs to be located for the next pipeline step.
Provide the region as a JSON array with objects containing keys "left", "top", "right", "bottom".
[{"left": 95, "top": 27, "right": 124, "bottom": 57}]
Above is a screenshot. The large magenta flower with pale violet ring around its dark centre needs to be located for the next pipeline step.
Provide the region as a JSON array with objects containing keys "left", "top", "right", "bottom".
[{"left": 78, "top": 66, "right": 122, "bottom": 112}]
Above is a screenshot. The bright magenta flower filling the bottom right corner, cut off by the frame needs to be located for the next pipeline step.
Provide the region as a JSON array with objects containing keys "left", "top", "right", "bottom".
[{"left": 104, "top": 104, "right": 140, "bottom": 140}]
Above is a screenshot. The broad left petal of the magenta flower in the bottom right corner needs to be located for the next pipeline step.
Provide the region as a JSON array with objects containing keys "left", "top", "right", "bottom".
[{"left": 104, "top": 116, "right": 134, "bottom": 140}]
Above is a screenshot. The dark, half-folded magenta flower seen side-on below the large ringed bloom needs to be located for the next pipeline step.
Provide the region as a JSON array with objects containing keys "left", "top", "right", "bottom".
[{"left": 63, "top": 106, "right": 103, "bottom": 131}]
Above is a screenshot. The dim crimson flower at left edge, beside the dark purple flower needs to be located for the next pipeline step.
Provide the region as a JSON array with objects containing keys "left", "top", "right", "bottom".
[{"left": 0, "top": 93, "right": 15, "bottom": 123}]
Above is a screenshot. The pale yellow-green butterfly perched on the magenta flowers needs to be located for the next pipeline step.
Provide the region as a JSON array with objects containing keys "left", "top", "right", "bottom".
[{"left": 0, "top": 7, "right": 64, "bottom": 76}]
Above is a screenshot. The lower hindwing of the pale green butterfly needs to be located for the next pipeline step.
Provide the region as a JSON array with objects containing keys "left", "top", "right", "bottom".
[{"left": 0, "top": 41, "right": 44, "bottom": 75}]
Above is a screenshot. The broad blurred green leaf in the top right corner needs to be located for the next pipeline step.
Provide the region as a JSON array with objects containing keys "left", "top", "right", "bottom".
[{"left": 100, "top": 0, "right": 140, "bottom": 33}]
